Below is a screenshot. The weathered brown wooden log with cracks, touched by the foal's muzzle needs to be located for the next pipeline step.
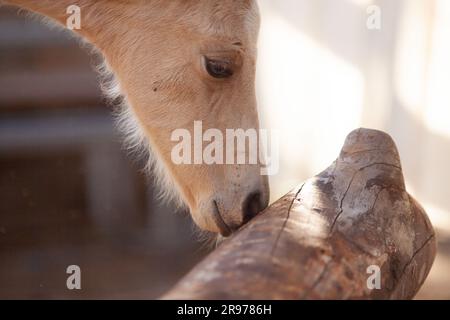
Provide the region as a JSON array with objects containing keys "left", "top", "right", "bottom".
[{"left": 162, "top": 129, "right": 436, "bottom": 299}]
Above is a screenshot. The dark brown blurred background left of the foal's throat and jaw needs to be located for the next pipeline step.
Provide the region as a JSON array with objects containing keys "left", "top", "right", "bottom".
[{"left": 0, "top": 7, "right": 207, "bottom": 299}]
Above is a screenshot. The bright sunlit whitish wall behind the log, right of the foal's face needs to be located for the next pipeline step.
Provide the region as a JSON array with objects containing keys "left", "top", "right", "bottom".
[{"left": 257, "top": 0, "right": 450, "bottom": 298}]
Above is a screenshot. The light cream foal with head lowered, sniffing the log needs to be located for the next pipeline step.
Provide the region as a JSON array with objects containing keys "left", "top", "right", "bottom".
[{"left": 0, "top": 0, "right": 269, "bottom": 236}]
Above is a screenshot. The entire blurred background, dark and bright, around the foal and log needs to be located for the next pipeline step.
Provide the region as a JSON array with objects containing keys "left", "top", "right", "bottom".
[{"left": 0, "top": 0, "right": 450, "bottom": 299}]
